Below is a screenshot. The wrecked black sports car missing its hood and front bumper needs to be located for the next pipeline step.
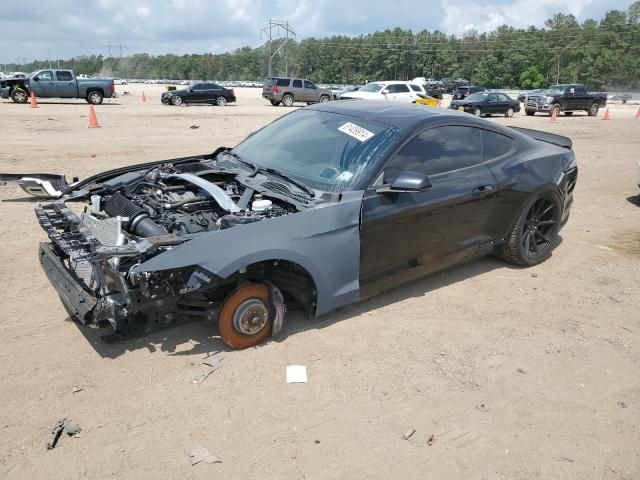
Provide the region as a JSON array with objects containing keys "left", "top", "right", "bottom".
[{"left": 36, "top": 100, "right": 578, "bottom": 348}]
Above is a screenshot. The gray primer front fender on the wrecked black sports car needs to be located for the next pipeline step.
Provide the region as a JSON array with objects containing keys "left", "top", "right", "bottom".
[{"left": 133, "top": 191, "right": 363, "bottom": 315}]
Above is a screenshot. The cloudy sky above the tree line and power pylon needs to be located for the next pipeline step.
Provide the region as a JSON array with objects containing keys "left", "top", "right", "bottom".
[{"left": 0, "top": 0, "right": 632, "bottom": 64}]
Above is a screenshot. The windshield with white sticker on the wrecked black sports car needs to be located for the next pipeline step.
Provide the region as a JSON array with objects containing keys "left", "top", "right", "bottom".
[{"left": 233, "top": 110, "right": 396, "bottom": 192}]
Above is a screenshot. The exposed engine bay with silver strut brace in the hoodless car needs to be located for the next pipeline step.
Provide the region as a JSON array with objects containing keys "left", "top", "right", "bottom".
[{"left": 83, "top": 166, "right": 296, "bottom": 245}]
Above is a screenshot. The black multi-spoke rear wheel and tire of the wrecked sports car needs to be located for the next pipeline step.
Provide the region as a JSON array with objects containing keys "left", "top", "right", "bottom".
[{"left": 498, "top": 191, "right": 561, "bottom": 266}]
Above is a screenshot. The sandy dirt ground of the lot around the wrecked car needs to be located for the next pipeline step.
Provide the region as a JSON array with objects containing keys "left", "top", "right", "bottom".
[{"left": 0, "top": 85, "right": 640, "bottom": 480}]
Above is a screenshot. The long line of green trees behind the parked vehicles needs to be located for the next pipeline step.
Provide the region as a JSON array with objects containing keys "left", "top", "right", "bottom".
[{"left": 7, "top": 1, "right": 640, "bottom": 90}]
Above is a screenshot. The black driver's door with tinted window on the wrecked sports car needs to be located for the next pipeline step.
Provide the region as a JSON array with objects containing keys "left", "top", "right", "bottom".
[{"left": 360, "top": 125, "right": 497, "bottom": 296}]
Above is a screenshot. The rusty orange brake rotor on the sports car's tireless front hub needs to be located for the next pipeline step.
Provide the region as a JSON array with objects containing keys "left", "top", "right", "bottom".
[{"left": 218, "top": 283, "right": 273, "bottom": 349}]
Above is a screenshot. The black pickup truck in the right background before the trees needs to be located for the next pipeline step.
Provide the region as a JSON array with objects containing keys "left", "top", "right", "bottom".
[{"left": 524, "top": 84, "right": 607, "bottom": 117}]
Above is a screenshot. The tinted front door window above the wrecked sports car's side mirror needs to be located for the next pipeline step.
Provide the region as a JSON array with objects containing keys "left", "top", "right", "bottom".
[{"left": 384, "top": 125, "right": 482, "bottom": 183}]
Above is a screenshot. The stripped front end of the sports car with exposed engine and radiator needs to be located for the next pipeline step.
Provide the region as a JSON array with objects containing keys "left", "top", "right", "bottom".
[{"left": 36, "top": 156, "right": 304, "bottom": 339}]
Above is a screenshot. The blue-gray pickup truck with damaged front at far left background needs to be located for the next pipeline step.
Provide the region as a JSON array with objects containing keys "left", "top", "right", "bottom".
[{"left": 0, "top": 69, "right": 115, "bottom": 105}]
